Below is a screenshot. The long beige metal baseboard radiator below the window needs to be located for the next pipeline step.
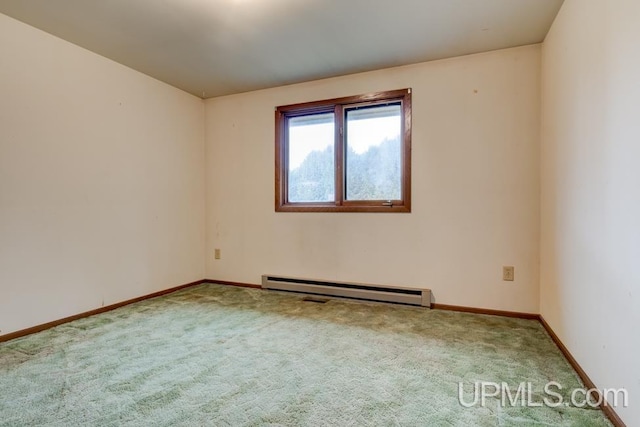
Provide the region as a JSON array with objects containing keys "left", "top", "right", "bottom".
[{"left": 262, "top": 274, "right": 431, "bottom": 308}]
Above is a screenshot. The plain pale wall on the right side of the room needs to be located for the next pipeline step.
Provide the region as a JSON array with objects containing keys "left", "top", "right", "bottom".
[{"left": 540, "top": 0, "right": 640, "bottom": 426}]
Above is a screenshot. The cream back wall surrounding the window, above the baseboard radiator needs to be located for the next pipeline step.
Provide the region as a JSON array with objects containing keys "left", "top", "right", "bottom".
[{"left": 205, "top": 46, "right": 540, "bottom": 313}]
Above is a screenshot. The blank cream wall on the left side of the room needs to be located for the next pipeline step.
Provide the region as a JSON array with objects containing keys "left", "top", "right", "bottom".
[{"left": 0, "top": 15, "right": 205, "bottom": 334}]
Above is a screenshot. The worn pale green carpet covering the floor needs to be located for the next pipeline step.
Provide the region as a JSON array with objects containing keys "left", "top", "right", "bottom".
[{"left": 0, "top": 284, "right": 610, "bottom": 427}]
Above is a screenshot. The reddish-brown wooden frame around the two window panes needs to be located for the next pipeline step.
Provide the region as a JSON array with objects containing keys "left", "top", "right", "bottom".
[{"left": 275, "top": 89, "right": 411, "bottom": 213}]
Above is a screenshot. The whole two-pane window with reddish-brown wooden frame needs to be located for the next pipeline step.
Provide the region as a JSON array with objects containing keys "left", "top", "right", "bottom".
[{"left": 275, "top": 89, "right": 411, "bottom": 212}]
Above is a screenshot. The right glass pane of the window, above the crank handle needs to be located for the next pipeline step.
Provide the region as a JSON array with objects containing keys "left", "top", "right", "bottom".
[{"left": 345, "top": 103, "right": 402, "bottom": 200}]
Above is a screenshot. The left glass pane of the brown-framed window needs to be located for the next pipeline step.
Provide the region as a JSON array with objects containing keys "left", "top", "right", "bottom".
[{"left": 288, "top": 113, "right": 335, "bottom": 203}]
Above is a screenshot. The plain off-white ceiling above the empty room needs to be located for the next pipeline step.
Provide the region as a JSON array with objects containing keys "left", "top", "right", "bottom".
[{"left": 0, "top": 0, "right": 562, "bottom": 98}]
